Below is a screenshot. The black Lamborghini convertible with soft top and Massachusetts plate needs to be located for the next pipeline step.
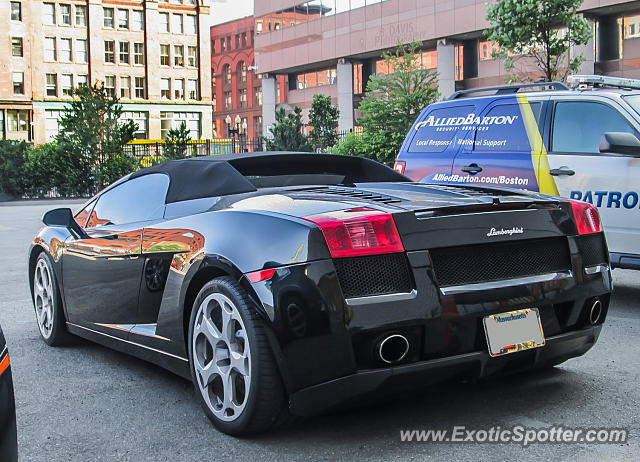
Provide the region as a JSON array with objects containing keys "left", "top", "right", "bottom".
[{"left": 28, "top": 153, "right": 612, "bottom": 435}]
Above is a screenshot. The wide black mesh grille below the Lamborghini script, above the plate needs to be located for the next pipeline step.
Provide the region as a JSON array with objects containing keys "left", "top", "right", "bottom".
[{"left": 429, "top": 238, "right": 571, "bottom": 286}]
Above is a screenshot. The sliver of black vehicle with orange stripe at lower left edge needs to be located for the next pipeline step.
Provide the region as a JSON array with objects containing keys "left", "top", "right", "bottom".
[{"left": 0, "top": 327, "right": 18, "bottom": 462}]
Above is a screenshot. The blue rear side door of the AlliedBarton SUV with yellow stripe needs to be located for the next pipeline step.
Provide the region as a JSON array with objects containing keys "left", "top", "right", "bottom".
[{"left": 452, "top": 95, "right": 543, "bottom": 191}]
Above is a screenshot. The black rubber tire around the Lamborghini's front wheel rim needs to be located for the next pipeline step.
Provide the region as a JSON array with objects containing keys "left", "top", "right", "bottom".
[{"left": 31, "top": 252, "right": 73, "bottom": 346}]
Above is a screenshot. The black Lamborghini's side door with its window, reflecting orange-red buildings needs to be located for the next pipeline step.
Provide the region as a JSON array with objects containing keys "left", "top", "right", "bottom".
[{"left": 62, "top": 174, "right": 169, "bottom": 338}]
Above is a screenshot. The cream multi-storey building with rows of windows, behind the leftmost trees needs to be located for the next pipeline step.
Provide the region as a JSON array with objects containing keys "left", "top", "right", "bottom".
[{"left": 0, "top": 0, "right": 212, "bottom": 144}]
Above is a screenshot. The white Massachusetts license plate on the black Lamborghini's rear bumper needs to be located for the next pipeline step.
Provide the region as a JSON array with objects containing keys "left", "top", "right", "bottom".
[{"left": 483, "top": 308, "right": 544, "bottom": 356}]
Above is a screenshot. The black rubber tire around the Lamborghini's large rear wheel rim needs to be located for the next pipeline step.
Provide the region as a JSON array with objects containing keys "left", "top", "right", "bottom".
[{"left": 188, "top": 277, "right": 287, "bottom": 436}]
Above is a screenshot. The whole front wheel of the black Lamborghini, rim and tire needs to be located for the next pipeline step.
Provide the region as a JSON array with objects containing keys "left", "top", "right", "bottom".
[{"left": 32, "top": 252, "right": 71, "bottom": 346}]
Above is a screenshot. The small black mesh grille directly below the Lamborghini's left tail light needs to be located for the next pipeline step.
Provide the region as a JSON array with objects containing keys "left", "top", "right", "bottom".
[{"left": 333, "top": 253, "right": 411, "bottom": 298}]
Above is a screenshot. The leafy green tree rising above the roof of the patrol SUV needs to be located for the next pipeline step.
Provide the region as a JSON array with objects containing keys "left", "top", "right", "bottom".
[{"left": 485, "top": 0, "right": 592, "bottom": 82}]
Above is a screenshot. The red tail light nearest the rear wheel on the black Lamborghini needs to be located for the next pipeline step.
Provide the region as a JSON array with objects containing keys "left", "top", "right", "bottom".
[{"left": 304, "top": 208, "right": 404, "bottom": 258}]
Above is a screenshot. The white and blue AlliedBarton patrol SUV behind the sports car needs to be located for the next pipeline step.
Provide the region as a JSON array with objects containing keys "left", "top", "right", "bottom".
[{"left": 395, "top": 75, "right": 640, "bottom": 269}]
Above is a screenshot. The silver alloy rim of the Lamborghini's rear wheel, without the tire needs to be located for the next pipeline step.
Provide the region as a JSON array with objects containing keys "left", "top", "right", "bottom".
[{"left": 192, "top": 293, "right": 251, "bottom": 422}]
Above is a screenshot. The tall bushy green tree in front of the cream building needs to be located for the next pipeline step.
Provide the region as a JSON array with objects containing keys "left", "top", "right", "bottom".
[{"left": 53, "top": 84, "right": 138, "bottom": 195}]
